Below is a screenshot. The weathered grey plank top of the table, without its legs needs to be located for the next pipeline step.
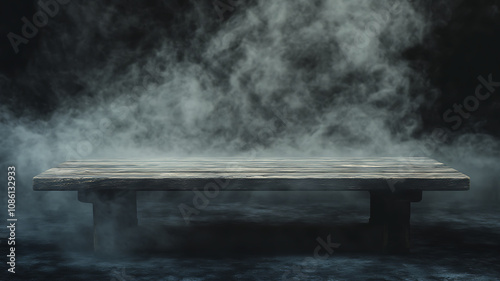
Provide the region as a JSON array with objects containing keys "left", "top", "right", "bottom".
[{"left": 33, "top": 157, "right": 470, "bottom": 191}]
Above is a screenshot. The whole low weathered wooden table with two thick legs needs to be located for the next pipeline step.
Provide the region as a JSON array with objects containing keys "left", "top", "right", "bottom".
[{"left": 33, "top": 157, "right": 470, "bottom": 253}]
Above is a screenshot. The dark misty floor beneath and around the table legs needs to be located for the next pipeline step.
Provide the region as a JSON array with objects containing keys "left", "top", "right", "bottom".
[{"left": 2, "top": 194, "right": 500, "bottom": 281}]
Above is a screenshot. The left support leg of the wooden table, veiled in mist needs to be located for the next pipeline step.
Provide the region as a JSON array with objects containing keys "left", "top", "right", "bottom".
[{"left": 78, "top": 190, "right": 137, "bottom": 255}]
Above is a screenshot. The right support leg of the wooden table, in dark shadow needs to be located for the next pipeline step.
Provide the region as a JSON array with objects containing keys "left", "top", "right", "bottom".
[{"left": 370, "top": 190, "right": 422, "bottom": 253}]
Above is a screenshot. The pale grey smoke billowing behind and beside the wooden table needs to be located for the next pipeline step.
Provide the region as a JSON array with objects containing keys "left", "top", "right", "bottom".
[{"left": 0, "top": 0, "right": 498, "bottom": 243}]
